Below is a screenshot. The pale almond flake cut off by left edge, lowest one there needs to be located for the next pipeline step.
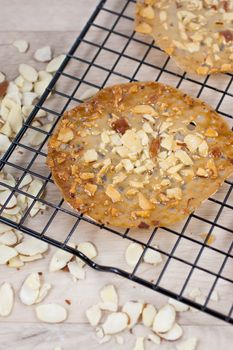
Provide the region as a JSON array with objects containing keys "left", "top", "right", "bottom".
[{"left": 0, "top": 282, "right": 14, "bottom": 316}]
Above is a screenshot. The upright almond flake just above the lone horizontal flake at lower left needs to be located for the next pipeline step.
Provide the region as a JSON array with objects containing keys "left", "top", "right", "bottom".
[{"left": 19, "top": 273, "right": 40, "bottom": 305}]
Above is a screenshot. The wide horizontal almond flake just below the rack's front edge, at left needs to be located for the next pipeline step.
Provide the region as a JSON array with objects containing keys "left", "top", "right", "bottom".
[{"left": 15, "top": 237, "right": 48, "bottom": 256}]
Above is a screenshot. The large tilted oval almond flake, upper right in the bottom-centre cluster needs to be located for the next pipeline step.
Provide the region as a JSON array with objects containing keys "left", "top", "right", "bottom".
[{"left": 152, "top": 304, "right": 176, "bottom": 333}]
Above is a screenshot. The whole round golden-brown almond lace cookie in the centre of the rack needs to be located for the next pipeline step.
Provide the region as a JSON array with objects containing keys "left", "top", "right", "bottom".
[{"left": 48, "top": 82, "right": 233, "bottom": 228}]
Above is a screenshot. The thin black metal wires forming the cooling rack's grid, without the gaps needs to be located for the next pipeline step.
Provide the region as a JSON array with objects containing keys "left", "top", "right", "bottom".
[{"left": 0, "top": 0, "right": 233, "bottom": 324}]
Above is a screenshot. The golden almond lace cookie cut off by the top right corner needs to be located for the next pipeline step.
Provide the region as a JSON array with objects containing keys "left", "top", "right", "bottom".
[{"left": 135, "top": 0, "right": 233, "bottom": 75}]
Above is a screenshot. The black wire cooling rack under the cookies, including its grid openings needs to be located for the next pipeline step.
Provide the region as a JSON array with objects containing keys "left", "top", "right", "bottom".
[{"left": 0, "top": 0, "right": 233, "bottom": 324}]
